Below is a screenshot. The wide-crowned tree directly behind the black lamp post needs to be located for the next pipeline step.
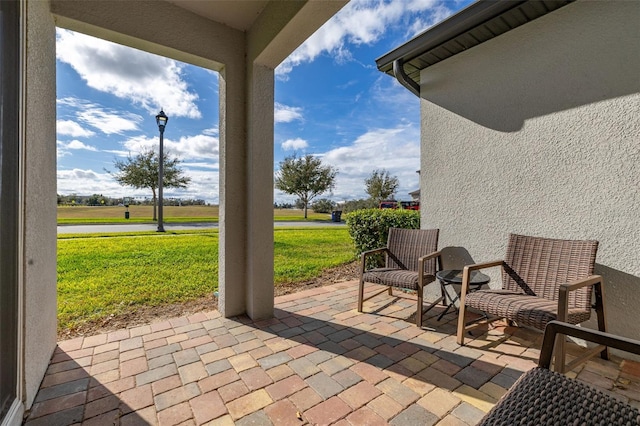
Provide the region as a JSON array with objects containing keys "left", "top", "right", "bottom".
[{"left": 107, "top": 149, "right": 191, "bottom": 220}]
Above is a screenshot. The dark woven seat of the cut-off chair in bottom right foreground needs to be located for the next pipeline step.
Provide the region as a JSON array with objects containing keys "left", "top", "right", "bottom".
[{"left": 479, "top": 367, "right": 640, "bottom": 426}]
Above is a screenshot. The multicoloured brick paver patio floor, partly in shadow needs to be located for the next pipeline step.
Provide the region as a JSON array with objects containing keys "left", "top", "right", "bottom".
[{"left": 26, "top": 282, "right": 640, "bottom": 426}]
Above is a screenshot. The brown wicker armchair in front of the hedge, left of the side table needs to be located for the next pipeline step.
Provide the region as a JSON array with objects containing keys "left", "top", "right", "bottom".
[{"left": 358, "top": 228, "right": 440, "bottom": 327}]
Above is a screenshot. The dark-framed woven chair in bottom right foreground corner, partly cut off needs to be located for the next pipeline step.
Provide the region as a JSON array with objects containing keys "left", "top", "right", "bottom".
[{"left": 479, "top": 321, "right": 640, "bottom": 426}]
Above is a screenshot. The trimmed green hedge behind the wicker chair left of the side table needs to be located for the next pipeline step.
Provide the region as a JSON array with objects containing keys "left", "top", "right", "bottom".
[{"left": 345, "top": 209, "right": 420, "bottom": 266}]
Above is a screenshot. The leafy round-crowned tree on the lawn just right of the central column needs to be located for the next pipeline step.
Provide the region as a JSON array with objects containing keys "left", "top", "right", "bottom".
[{"left": 275, "top": 154, "right": 338, "bottom": 219}]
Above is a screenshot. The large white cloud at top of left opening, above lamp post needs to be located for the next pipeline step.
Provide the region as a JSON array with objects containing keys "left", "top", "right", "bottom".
[{"left": 56, "top": 29, "right": 201, "bottom": 118}]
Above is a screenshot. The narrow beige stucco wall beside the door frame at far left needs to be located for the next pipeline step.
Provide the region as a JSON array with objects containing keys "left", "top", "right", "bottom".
[{"left": 22, "top": 1, "right": 57, "bottom": 408}]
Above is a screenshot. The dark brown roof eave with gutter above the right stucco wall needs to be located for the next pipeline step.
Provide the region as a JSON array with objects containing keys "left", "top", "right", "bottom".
[{"left": 376, "top": 0, "right": 575, "bottom": 95}]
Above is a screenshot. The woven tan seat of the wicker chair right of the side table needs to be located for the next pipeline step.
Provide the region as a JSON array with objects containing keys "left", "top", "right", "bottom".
[{"left": 465, "top": 290, "right": 591, "bottom": 330}]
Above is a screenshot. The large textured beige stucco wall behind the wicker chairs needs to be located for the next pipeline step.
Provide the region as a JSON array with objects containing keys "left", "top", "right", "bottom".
[{"left": 421, "top": 1, "right": 640, "bottom": 338}]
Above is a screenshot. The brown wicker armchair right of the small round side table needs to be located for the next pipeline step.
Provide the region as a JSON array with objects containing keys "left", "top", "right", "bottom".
[{"left": 457, "top": 234, "right": 609, "bottom": 373}]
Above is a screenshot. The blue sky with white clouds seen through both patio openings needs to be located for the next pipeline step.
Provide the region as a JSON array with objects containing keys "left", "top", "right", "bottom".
[{"left": 57, "top": 0, "right": 471, "bottom": 204}]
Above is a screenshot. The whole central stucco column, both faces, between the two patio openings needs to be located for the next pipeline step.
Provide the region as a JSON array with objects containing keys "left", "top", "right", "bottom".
[{"left": 218, "top": 60, "right": 274, "bottom": 319}]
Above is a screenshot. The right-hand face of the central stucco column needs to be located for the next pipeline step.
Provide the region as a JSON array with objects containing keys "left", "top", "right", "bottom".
[{"left": 246, "top": 64, "right": 274, "bottom": 319}]
